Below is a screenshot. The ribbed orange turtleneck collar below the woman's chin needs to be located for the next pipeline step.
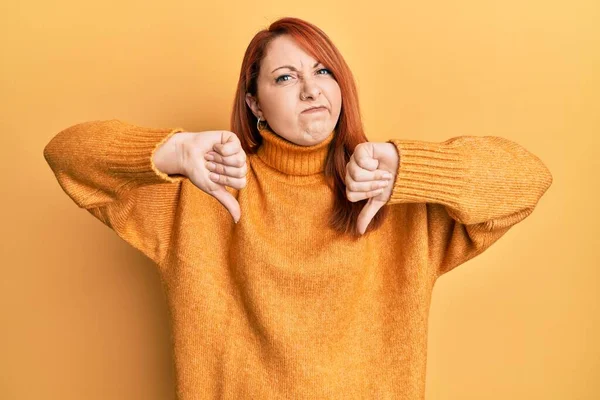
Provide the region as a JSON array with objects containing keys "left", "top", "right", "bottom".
[{"left": 256, "top": 126, "right": 335, "bottom": 175}]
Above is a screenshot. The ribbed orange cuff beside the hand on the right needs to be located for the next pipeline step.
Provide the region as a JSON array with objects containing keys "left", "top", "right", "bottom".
[{"left": 386, "top": 139, "right": 467, "bottom": 208}]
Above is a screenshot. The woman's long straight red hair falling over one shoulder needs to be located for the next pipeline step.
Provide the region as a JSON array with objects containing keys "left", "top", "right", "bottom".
[{"left": 230, "top": 17, "right": 388, "bottom": 238}]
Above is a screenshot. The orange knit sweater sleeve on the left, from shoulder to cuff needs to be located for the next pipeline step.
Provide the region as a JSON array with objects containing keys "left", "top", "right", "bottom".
[{"left": 44, "top": 119, "right": 186, "bottom": 264}]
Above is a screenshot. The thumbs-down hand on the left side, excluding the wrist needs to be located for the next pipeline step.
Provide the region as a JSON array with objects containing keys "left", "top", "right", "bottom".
[{"left": 180, "top": 131, "right": 248, "bottom": 223}]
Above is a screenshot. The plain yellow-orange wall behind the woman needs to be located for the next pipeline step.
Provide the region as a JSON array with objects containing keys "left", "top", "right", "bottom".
[{"left": 0, "top": 0, "right": 600, "bottom": 400}]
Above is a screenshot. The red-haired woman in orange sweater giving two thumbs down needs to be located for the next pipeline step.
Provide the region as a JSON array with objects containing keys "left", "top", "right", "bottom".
[{"left": 44, "top": 18, "right": 552, "bottom": 399}]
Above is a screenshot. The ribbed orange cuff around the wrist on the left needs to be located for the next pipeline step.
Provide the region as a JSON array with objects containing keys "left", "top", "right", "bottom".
[{"left": 106, "top": 119, "right": 186, "bottom": 186}]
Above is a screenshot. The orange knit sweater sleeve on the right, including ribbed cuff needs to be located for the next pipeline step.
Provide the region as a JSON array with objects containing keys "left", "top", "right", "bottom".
[{"left": 386, "top": 136, "right": 553, "bottom": 276}]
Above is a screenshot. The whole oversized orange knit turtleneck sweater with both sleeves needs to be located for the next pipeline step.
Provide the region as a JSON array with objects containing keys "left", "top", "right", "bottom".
[{"left": 44, "top": 120, "right": 552, "bottom": 400}]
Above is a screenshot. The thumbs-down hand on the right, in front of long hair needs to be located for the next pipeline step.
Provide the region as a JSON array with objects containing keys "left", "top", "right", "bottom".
[{"left": 345, "top": 142, "right": 400, "bottom": 235}]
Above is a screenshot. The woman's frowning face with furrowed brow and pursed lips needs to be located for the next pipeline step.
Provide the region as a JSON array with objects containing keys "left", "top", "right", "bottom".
[{"left": 246, "top": 35, "right": 342, "bottom": 146}]
